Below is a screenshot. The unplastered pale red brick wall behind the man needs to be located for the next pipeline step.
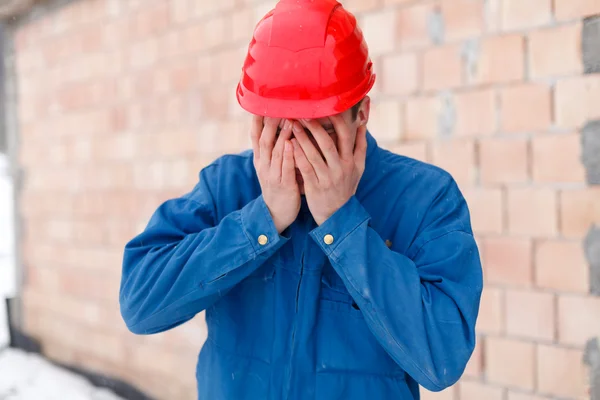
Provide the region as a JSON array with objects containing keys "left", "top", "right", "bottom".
[{"left": 7, "top": 0, "right": 600, "bottom": 400}]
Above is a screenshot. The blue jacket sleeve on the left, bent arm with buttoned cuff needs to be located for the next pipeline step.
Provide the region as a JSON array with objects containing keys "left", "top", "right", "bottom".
[{"left": 119, "top": 166, "right": 288, "bottom": 334}]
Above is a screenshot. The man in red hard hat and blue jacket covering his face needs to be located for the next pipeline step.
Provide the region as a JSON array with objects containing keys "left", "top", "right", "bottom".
[{"left": 120, "top": 0, "right": 482, "bottom": 400}]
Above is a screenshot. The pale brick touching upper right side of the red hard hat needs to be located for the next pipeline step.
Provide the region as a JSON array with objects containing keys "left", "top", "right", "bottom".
[{"left": 360, "top": 10, "right": 398, "bottom": 56}]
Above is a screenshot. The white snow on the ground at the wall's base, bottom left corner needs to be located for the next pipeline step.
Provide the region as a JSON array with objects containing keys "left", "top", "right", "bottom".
[{"left": 0, "top": 348, "right": 123, "bottom": 400}]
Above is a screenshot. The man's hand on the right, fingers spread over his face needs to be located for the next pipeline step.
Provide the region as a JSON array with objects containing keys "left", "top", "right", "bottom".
[{"left": 292, "top": 116, "right": 367, "bottom": 225}]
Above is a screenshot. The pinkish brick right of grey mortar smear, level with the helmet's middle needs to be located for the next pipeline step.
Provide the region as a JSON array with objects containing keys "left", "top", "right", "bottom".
[{"left": 470, "top": 35, "right": 525, "bottom": 84}]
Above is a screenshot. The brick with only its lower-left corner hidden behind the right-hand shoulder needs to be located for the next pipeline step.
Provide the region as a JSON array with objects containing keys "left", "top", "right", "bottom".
[{"left": 432, "top": 140, "right": 477, "bottom": 186}]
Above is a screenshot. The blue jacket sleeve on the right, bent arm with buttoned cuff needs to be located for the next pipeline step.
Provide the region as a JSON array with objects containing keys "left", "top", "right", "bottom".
[{"left": 311, "top": 180, "right": 483, "bottom": 391}]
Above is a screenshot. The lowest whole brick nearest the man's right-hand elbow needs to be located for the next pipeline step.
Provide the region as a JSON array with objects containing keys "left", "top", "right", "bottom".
[{"left": 488, "top": 337, "right": 535, "bottom": 390}]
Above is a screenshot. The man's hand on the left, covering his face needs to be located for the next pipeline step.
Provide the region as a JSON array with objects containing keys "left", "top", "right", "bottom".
[{"left": 250, "top": 116, "right": 300, "bottom": 233}]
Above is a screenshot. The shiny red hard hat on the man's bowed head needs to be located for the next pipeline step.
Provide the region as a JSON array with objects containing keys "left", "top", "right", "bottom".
[{"left": 236, "top": 0, "right": 375, "bottom": 119}]
